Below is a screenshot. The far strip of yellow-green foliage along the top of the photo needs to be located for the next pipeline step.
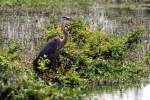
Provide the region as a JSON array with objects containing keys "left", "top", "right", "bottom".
[{"left": 0, "top": 0, "right": 143, "bottom": 9}]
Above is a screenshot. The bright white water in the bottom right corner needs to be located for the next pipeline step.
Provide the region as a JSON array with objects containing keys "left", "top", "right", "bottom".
[{"left": 84, "top": 84, "right": 150, "bottom": 100}]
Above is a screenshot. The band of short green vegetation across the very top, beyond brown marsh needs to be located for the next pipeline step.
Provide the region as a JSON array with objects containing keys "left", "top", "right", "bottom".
[{"left": 0, "top": 0, "right": 143, "bottom": 7}]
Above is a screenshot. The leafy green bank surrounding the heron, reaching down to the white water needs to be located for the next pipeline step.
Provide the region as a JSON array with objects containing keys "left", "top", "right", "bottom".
[{"left": 0, "top": 19, "right": 150, "bottom": 100}]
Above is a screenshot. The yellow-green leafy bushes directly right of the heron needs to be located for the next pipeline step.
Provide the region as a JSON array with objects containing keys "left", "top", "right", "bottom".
[{"left": 46, "top": 19, "right": 147, "bottom": 83}]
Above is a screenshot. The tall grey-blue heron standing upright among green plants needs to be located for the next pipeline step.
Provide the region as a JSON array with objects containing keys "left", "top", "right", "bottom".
[{"left": 33, "top": 16, "right": 71, "bottom": 69}]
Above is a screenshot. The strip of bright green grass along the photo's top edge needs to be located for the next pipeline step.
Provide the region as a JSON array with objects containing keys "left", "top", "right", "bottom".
[{"left": 0, "top": 0, "right": 145, "bottom": 10}]
